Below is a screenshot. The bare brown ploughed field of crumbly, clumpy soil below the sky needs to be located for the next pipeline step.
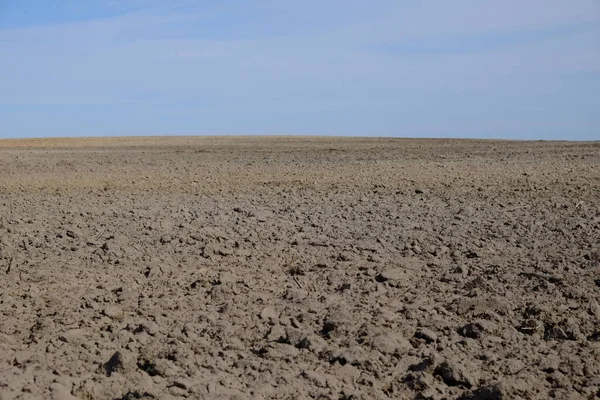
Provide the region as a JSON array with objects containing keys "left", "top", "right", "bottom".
[{"left": 0, "top": 137, "right": 600, "bottom": 400}]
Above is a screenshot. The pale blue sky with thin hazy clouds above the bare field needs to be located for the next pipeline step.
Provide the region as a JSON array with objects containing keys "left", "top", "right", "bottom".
[{"left": 0, "top": 0, "right": 600, "bottom": 140}]
